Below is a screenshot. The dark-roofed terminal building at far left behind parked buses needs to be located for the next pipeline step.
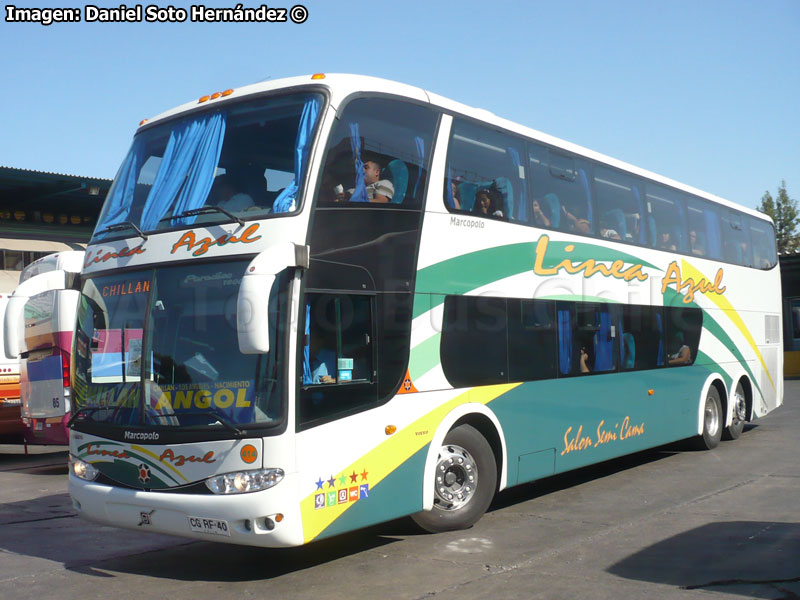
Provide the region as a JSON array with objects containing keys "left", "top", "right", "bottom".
[{"left": 0, "top": 166, "right": 111, "bottom": 294}]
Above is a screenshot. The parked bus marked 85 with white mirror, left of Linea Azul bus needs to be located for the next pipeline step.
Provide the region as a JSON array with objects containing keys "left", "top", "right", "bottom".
[{"left": 4, "top": 250, "right": 84, "bottom": 445}]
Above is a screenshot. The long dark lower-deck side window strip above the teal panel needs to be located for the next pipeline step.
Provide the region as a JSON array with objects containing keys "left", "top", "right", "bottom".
[{"left": 440, "top": 296, "right": 702, "bottom": 387}]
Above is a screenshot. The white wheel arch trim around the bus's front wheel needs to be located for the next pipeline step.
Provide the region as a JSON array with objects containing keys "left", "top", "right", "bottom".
[{"left": 422, "top": 403, "right": 508, "bottom": 510}]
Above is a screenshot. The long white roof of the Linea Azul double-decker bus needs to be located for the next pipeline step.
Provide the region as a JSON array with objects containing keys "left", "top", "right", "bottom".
[{"left": 142, "top": 73, "right": 772, "bottom": 222}]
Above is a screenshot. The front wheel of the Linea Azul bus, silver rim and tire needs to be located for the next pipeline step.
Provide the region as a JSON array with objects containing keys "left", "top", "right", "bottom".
[{"left": 411, "top": 425, "right": 497, "bottom": 533}]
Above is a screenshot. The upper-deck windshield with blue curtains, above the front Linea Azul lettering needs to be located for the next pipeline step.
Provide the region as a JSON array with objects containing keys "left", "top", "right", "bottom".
[{"left": 92, "top": 94, "right": 322, "bottom": 241}]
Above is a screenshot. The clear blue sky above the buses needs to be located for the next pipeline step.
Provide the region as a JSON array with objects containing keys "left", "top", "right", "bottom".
[{"left": 0, "top": 0, "right": 800, "bottom": 208}]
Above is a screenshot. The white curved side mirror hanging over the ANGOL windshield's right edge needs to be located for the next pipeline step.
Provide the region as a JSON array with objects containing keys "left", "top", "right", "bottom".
[{"left": 236, "top": 242, "right": 309, "bottom": 354}]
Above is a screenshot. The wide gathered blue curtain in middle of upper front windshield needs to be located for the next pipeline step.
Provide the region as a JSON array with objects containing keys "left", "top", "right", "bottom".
[{"left": 140, "top": 113, "right": 225, "bottom": 231}]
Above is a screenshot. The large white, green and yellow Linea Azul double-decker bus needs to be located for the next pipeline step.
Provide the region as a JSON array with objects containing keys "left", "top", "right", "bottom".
[{"left": 69, "top": 74, "right": 783, "bottom": 546}]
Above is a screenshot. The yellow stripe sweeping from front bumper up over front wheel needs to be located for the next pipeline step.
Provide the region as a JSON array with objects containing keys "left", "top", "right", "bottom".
[{"left": 300, "top": 383, "right": 521, "bottom": 543}]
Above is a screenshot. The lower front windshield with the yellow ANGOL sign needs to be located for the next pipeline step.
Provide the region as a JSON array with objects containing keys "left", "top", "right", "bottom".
[{"left": 73, "top": 261, "right": 287, "bottom": 427}]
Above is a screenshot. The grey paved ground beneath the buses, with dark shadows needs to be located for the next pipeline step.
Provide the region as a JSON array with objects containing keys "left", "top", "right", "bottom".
[{"left": 0, "top": 381, "right": 800, "bottom": 600}]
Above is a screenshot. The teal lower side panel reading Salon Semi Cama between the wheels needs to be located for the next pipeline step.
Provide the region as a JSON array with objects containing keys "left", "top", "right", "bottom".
[{"left": 490, "top": 366, "right": 709, "bottom": 485}]
